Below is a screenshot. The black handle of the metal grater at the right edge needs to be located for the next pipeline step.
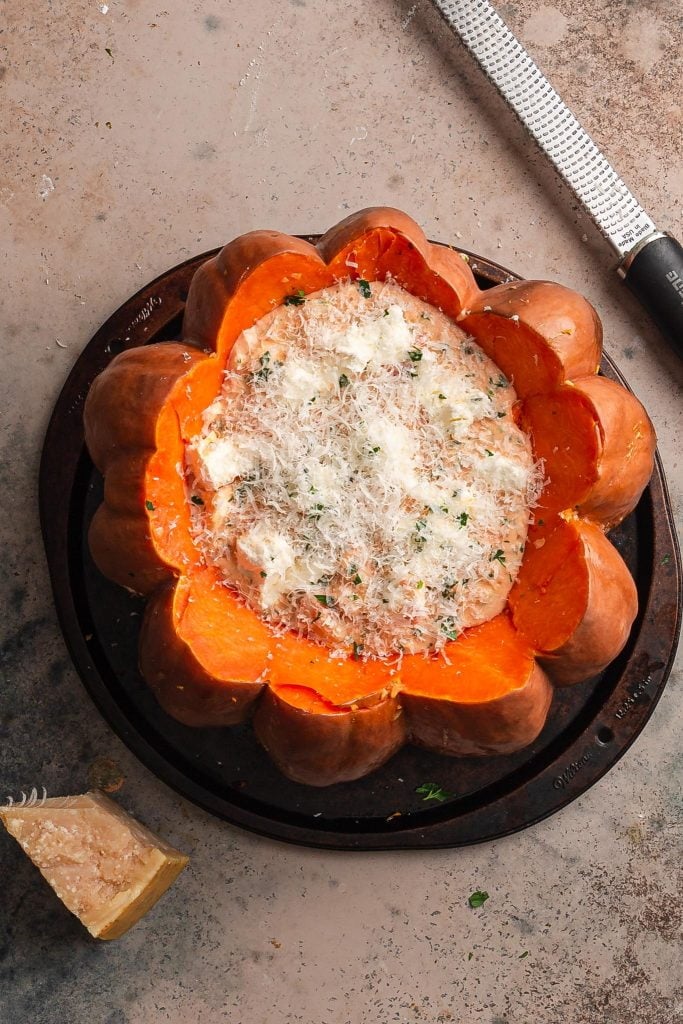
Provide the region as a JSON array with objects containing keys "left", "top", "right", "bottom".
[{"left": 618, "top": 234, "right": 683, "bottom": 356}]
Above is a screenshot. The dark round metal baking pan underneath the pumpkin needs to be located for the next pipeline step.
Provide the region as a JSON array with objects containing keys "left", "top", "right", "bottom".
[{"left": 40, "top": 238, "right": 681, "bottom": 850}]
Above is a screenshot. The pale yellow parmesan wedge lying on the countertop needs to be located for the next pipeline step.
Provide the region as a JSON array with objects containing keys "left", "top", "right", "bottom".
[{"left": 0, "top": 792, "right": 189, "bottom": 939}]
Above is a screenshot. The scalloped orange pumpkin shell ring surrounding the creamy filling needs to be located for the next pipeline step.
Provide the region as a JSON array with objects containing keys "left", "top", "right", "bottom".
[{"left": 85, "top": 208, "right": 654, "bottom": 785}]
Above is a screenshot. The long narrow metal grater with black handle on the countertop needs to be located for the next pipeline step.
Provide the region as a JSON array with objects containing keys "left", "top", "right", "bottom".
[{"left": 433, "top": 0, "right": 683, "bottom": 352}]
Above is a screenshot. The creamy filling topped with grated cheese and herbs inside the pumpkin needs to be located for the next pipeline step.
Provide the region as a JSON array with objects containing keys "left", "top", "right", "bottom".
[{"left": 186, "top": 281, "right": 541, "bottom": 657}]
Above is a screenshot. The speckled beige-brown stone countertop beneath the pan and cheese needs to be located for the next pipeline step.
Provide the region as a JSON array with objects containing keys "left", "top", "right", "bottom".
[{"left": 0, "top": 0, "right": 683, "bottom": 1024}]
